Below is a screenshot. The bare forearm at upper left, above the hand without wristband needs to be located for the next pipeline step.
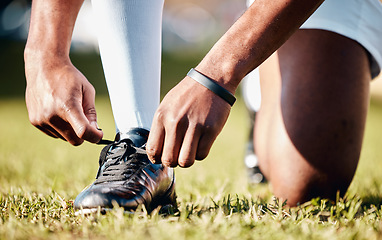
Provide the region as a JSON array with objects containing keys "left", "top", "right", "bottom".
[{"left": 24, "top": 0, "right": 83, "bottom": 63}]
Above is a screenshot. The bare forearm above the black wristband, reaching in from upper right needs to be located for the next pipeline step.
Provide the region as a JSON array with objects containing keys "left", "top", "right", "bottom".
[{"left": 196, "top": 0, "right": 323, "bottom": 93}]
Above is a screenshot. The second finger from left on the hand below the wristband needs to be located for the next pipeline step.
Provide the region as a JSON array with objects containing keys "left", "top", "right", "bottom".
[{"left": 161, "top": 117, "right": 188, "bottom": 167}]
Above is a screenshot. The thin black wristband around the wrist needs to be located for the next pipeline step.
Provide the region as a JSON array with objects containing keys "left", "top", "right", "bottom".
[{"left": 187, "top": 68, "right": 236, "bottom": 106}]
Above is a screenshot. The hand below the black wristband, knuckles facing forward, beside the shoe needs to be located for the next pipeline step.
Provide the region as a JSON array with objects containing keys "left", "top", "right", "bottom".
[{"left": 146, "top": 77, "right": 231, "bottom": 167}]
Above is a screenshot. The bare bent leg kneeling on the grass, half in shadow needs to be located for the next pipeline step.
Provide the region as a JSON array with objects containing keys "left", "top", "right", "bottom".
[{"left": 255, "top": 30, "right": 371, "bottom": 206}]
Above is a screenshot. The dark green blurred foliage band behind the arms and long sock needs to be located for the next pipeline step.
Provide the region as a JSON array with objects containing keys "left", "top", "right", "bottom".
[{"left": 0, "top": 39, "right": 204, "bottom": 98}]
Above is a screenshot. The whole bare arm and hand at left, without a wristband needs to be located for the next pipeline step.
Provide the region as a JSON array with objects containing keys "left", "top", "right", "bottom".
[{"left": 24, "top": 0, "right": 103, "bottom": 145}]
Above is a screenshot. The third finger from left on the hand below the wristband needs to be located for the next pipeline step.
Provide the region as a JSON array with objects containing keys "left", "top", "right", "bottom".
[{"left": 178, "top": 124, "right": 201, "bottom": 168}]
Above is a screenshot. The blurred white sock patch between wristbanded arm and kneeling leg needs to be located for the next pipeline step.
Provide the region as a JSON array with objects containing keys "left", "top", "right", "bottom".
[{"left": 241, "top": 68, "right": 261, "bottom": 113}]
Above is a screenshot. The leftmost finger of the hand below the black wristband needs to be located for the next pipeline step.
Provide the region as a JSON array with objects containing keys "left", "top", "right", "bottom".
[{"left": 146, "top": 118, "right": 165, "bottom": 163}]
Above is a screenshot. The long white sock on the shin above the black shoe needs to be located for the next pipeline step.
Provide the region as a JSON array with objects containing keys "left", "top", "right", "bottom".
[{"left": 92, "top": 0, "right": 164, "bottom": 138}]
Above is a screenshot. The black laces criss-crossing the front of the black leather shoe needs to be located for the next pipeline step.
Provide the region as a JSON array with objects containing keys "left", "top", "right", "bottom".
[{"left": 94, "top": 139, "right": 149, "bottom": 184}]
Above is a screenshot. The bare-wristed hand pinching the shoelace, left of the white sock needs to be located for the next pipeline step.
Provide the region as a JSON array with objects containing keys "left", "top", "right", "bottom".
[{"left": 25, "top": 56, "right": 103, "bottom": 146}]
